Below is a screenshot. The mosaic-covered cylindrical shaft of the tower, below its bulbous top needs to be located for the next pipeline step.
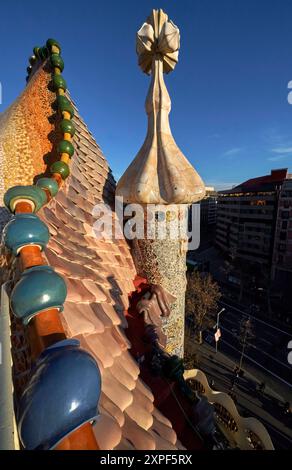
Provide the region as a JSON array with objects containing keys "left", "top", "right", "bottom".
[{"left": 132, "top": 204, "right": 188, "bottom": 357}]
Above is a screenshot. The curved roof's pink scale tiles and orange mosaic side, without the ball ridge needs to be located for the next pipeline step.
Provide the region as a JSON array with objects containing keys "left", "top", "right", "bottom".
[{"left": 0, "top": 38, "right": 180, "bottom": 449}]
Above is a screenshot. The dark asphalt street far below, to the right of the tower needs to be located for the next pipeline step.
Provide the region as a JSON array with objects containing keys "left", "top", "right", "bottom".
[{"left": 186, "top": 304, "right": 292, "bottom": 449}]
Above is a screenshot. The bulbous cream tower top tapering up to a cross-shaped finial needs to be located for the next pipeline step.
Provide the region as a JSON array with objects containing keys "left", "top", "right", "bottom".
[{"left": 116, "top": 10, "right": 205, "bottom": 204}]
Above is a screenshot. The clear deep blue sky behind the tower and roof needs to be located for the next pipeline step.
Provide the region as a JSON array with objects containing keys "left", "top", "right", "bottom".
[{"left": 0, "top": 0, "right": 292, "bottom": 188}]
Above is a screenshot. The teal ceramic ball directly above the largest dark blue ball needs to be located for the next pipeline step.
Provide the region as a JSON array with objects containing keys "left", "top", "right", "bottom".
[{"left": 10, "top": 266, "right": 67, "bottom": 325}]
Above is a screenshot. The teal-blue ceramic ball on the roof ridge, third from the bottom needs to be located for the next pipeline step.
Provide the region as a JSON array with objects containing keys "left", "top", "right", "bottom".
[{"left": 3, "top": 214, "right": 50, "bottom": 256}]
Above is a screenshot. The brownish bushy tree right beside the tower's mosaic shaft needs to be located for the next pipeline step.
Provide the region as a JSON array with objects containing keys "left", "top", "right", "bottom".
[{"left": 186, "top": 271, "right": 221, "bottom": 344}]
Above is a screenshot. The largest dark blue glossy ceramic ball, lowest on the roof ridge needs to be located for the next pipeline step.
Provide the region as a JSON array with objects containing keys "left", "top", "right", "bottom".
[{"left": 17, "top": 340, "right": 101, "bottom": 450}]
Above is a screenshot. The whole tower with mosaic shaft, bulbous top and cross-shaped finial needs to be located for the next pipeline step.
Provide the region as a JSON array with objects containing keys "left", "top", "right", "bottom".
[{"left": 117, "top": 10, "right": 205, "bottom": 357}]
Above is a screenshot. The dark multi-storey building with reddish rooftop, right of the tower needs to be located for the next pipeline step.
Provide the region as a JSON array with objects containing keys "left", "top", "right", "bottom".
[{"left": 216, "top": 169, "right": 289, "bottom": 278}]
